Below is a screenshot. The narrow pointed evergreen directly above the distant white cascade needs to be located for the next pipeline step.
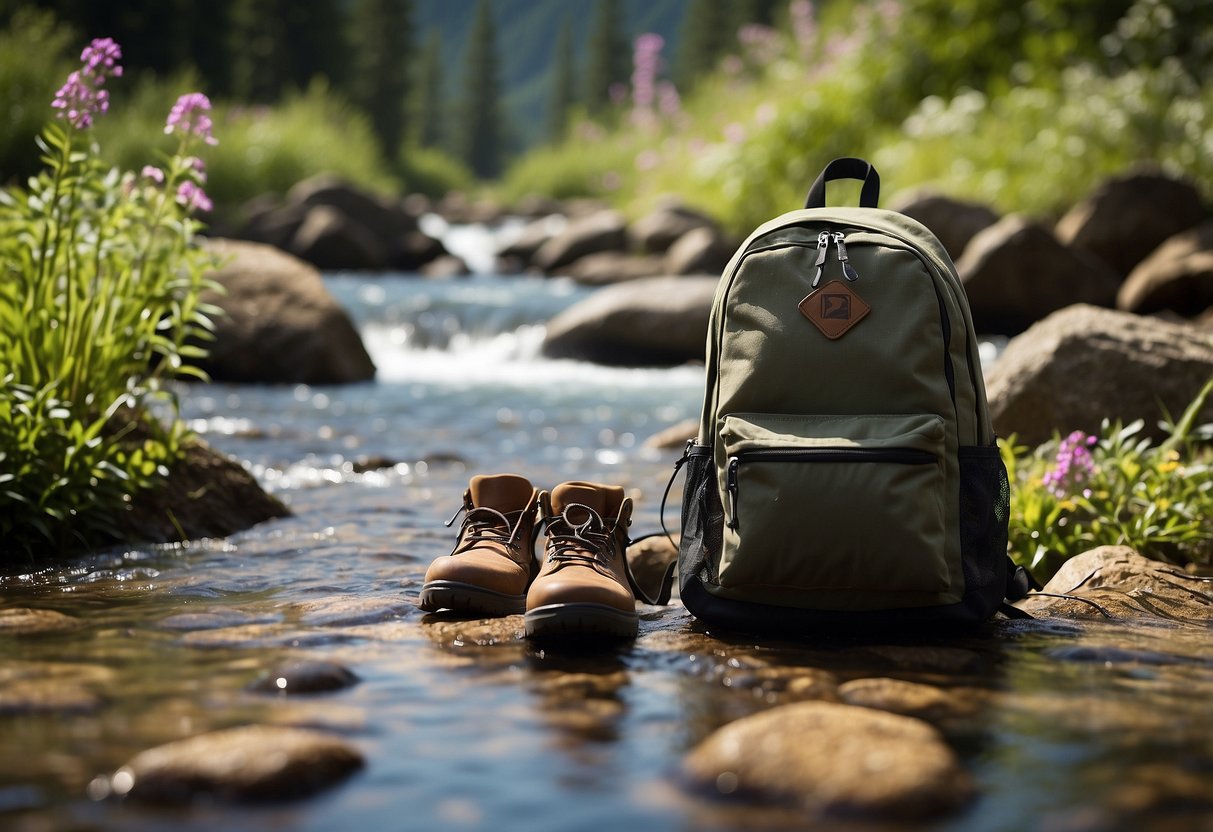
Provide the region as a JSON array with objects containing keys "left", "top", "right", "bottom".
[{"left": 459, "top": 0, "right": 502, "bottom": 178}]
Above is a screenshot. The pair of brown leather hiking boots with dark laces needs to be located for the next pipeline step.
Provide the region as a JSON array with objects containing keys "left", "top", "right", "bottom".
[{"left": 420, "top": 474, "right": 665, "bottom": 638}]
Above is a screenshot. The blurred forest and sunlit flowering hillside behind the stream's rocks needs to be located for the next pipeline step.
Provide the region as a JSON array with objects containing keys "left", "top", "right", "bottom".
[{"left": 0, "top": 0, "right": 1213, "bottom": 232}]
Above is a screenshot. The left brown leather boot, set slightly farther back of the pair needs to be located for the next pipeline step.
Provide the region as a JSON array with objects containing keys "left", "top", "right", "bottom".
[{"left": 420, "top": 474, "right": 539, "bottom": 616}]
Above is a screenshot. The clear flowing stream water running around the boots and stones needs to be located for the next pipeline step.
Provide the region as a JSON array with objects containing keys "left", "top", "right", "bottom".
[{"left": 0, "top": 229, "right": 1213, "bottom": 832}]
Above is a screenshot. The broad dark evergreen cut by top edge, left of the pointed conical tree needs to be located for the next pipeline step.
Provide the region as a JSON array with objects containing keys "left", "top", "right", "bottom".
[{"left": 349, "top": 0, "right": 412, "bottom": 160}]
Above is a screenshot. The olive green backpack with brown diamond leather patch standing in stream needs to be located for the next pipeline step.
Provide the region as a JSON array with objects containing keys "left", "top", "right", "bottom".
[{"left": 676, "top": 158, "right": 1029, "bottom": 634}]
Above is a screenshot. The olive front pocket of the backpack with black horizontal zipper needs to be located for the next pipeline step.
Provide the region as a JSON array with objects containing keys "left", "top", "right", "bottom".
[{"left": 717, "top": 414, "right": 949, "bottom": 599}]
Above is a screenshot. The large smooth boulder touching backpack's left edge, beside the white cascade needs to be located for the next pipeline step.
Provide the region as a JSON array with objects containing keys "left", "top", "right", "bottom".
[{"left": 543, "top": 278, "right": 717, "bottom": 366}]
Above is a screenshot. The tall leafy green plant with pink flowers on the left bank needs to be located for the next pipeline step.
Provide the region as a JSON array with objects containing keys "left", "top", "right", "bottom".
[{"left": 0, "top": 39, "right": 218, "bottom": 558}]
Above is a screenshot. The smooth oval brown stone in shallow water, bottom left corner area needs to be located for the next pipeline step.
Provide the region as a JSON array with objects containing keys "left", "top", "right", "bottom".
[{"left": 110, "top": 725, "right": 363, "bottom": 804}]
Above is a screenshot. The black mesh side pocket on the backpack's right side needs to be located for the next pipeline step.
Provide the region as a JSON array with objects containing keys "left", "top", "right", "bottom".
[{"left": 959, "top": 445, "right": 1010, "bottom": 612}]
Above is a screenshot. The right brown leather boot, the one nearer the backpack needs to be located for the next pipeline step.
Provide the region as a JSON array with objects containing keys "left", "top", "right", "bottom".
[{"left": 524, "top": 483, "right": 639, "bottom": 638}]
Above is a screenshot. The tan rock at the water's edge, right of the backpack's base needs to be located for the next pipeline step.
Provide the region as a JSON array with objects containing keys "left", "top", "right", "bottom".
[{"left": 1015, "top": 546, "right": 1213, "bottom": 625}]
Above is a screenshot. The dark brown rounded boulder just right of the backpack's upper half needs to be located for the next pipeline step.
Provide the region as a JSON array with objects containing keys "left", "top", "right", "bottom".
[{"left": 956, "top": 216, "right": 1120, "bottom": 335}]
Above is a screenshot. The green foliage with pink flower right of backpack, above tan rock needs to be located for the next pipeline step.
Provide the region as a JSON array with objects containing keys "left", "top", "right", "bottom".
[{"left": 1000, "top": 380, "right": 1213, "bottom": 582}]
